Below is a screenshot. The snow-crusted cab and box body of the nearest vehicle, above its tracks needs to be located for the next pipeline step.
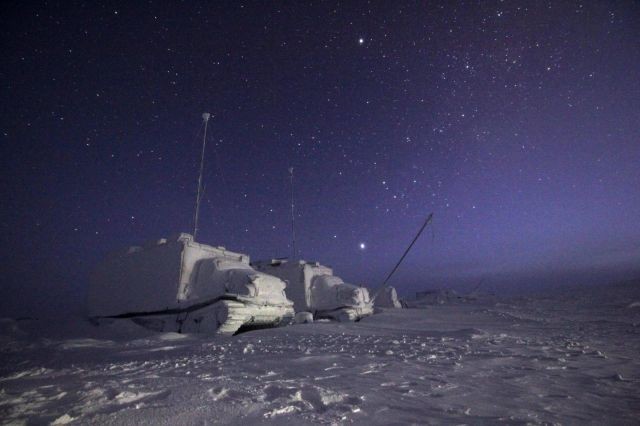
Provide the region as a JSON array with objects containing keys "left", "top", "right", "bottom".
[{"left": 88, "top": 234, "right": 292, "bottom": 317}]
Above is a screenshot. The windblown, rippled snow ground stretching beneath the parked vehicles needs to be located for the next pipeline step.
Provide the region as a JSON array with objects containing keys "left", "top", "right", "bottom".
[{"left": 0, "top": 284, "right": 640, "bottom": 425}]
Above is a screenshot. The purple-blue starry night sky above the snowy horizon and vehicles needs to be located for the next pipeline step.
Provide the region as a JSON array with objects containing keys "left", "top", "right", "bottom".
[{"left": 0, "top": 1, "right": 640, "bottom": 313}]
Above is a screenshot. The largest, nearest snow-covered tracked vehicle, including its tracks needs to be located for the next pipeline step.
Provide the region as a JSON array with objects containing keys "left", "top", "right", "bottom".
[{"left": 88, "top": 233, "right": 294, "bottom": 334}]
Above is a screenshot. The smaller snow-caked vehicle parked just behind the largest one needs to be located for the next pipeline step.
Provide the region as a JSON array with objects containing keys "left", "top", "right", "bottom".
[{"left": 252, "top": 259, "right": 373, "bottom": 321}]
